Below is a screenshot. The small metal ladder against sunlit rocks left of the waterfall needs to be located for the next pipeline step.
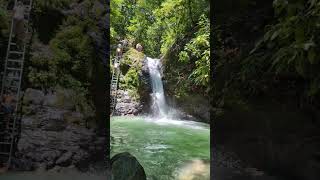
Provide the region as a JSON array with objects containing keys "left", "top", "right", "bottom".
[{"left": 110, "top": 56, "right": 121, "bottom": 115}]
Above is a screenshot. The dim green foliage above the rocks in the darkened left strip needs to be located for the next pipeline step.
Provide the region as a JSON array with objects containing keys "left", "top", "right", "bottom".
[{"left": 28, "top": 0, "right": 105, "bottom": 112}]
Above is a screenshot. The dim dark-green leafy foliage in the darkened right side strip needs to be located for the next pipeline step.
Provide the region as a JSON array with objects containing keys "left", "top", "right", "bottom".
[{"left": 214, "top": 0, "right": 320, "bottom": 107}]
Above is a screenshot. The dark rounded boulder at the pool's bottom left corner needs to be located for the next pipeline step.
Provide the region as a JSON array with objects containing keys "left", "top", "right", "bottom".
[{"left": 111, "top": 152, "right": 147, "bottom": 180}]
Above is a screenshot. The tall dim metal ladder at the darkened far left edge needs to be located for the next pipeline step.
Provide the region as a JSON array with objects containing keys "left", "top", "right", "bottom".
[{"left": 0, "top": 0, "right": 32, "bottom": 168}]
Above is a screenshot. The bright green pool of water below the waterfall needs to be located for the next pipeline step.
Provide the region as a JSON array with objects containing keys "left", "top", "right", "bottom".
[{"left": 111, "top": 117, "right": 210, "bottom": 180}]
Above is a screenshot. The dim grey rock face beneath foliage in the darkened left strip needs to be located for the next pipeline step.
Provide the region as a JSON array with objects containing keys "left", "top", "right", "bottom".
[{"left": 14, "top": 89, "right": 105, "bottom": 171}]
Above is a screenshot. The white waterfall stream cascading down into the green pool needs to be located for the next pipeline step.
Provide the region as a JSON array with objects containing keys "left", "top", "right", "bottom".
[{"left": 147, "top": 57, "right": 168, "bottom": 117}]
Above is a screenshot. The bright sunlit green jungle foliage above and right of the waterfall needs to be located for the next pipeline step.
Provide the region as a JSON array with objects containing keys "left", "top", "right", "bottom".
[{"left": 110, "top": 0, "right": 210, "bottom": 95}]
